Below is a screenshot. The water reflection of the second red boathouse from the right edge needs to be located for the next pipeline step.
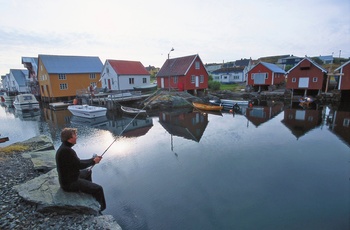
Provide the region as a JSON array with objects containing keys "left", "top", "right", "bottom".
[{"left": 282, "top": 106, "right": 323, "bottom": 139}]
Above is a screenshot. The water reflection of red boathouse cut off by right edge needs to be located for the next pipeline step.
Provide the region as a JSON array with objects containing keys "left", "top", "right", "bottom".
[{"left": 326, "top": 106, "right": 350, "bottom": 146}]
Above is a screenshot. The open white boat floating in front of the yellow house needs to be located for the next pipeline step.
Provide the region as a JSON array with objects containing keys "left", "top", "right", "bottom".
[{"left": 68, "top": 105, "right": 107, "bottom": 118}]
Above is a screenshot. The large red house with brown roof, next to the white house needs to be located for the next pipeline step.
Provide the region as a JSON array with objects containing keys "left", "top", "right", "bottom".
[{"left": 157, "top": 54, "right": 209, "bottom": 95}]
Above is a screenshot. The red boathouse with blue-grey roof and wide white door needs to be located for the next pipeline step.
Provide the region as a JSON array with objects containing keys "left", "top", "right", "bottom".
[{"left": 247, "top": 62, "right": 286, "bottom": 92}]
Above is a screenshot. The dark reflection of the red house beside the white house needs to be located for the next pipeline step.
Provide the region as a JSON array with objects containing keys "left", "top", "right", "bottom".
[{"left": 159, "top": 111, "right": 208, "bottom": 142}]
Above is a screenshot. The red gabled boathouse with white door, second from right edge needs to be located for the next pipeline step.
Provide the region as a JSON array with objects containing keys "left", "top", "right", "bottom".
[{"left": 286, "top": 57, "right": 327, "bottom": 96}]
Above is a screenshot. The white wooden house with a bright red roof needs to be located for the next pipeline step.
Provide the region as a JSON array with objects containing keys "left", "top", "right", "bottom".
[{"left": 101, "top": 60, "right": 151, "bottom": 90}]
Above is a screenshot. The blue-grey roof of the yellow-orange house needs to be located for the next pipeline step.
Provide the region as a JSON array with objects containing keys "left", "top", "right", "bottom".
[{"left": 39, "top": 54, "right": 103, "bottom": 74}]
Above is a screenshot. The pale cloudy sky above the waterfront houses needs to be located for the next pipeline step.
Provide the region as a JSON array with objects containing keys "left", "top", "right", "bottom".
[{"left": 0, "top": 0, "right": 350, "bottom": 75}]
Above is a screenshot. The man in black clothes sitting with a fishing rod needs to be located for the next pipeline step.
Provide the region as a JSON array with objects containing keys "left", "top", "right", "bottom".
[{"left": 56, "top": 128, "right": 106, "bottom": 211}]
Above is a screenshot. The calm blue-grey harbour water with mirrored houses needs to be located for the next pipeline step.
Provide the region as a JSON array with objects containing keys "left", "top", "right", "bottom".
[{"left": 0, "top": 102, "right": 350, "bottom": 230}]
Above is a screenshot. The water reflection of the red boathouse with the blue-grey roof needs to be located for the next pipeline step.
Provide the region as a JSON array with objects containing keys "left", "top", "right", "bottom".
[{"left": 245, "top": 101, "right": 284, "bottom": 127}]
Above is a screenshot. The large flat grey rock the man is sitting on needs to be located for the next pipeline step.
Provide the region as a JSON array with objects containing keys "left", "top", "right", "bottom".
[{"left": 14, "top": 169, "right": 100, "bottom": 215}]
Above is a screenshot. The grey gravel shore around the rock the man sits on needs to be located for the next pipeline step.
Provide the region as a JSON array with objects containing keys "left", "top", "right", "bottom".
[{"left": 0, "top": 154, "right": 102, "bottom": 230}]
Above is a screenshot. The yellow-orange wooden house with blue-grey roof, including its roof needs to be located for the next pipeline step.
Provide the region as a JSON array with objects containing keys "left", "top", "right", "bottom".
[{"left": 37, "top": 55, "right": 103, "bottom": 102}]
